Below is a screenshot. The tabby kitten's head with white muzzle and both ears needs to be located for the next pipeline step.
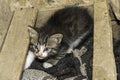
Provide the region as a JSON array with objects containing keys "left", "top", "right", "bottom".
[{"left": 28, "top": 27, "right": 63, "bottom": 59}]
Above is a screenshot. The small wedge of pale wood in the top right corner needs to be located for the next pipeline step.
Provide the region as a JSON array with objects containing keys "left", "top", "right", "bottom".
[{"left": 111, "top": 0, "right": 120, "bottom": 20}]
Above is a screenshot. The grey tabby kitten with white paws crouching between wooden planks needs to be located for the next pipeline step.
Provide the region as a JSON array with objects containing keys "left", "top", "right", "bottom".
[{"left": 25, "top": 7, "right": 93, "bottom": 68}]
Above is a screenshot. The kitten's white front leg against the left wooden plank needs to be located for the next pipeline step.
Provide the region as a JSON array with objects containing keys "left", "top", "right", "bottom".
[{"left": 24, "top": 51, "right": 35, "bottom": 70}]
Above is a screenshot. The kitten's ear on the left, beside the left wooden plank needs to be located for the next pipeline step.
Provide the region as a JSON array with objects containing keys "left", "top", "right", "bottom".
[{"left": 28, "top": 27, "right": 38, "bottom": 44}]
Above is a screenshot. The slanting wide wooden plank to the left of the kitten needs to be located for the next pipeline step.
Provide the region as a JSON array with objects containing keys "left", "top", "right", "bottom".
[{"left": 0, "top": 9, "right": 37, "bottom": 80}]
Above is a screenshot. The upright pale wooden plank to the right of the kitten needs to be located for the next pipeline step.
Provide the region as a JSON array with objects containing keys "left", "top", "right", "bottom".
[{"left": 93, "top": 0, "right": 117, "bottom": 80}]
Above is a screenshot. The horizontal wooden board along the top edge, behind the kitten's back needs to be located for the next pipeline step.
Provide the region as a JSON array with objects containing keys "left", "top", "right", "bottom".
[{"left": 19, "top": 0, "right": 93, "bottom": 11}]
